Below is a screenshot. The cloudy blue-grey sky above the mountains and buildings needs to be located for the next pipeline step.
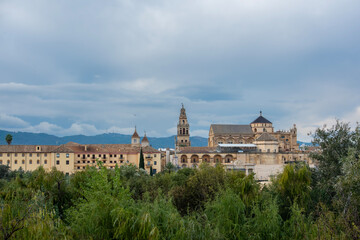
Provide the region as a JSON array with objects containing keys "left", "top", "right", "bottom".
[{"left": 0, "top": 0, "right": 360, "bottom": 141}]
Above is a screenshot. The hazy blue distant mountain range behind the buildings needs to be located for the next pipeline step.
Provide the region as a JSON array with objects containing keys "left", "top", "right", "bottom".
[{"left": 0, "top": 130, "right": 208, "bottom": 149}]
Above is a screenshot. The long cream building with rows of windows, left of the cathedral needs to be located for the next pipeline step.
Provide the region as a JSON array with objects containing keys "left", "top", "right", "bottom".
[{"left": 0, "top": 129, "right": 161, "bottom": 174}]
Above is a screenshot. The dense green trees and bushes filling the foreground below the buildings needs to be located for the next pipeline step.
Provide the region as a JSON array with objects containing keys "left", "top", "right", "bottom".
[{"left": 0, "top": 123, "right": 360, "bottom": 239}]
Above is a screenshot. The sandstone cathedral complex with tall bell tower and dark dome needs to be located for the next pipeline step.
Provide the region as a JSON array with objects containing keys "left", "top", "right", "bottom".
[{"left": 171, "top": 105, "right": 312, "bottom": 182}]
